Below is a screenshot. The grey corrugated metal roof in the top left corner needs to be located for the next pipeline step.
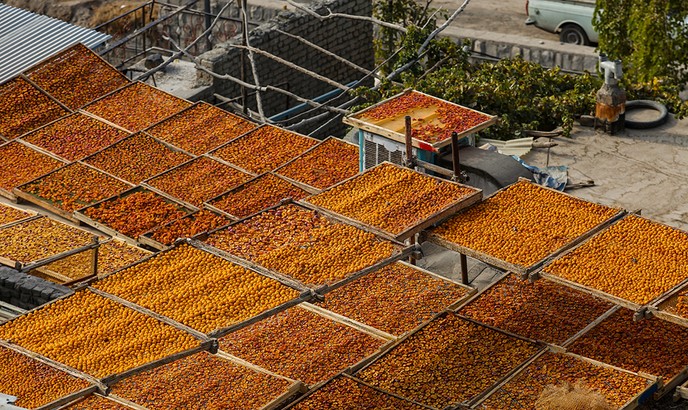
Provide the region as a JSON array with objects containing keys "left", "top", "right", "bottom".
[{"left": 0, "top": 3, "right": 111, "bottom": 83}]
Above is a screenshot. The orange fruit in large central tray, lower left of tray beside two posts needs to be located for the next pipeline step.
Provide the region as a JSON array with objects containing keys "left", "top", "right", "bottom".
[{"left": 206, "top": 205, "right": 395, "bottom": 285}]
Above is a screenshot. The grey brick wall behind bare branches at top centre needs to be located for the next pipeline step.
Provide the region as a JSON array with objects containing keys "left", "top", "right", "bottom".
[{"left": 198, "top": 0, "right": 375, "bottom": 135}]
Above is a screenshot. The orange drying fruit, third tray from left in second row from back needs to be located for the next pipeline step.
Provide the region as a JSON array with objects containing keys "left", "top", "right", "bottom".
[{"left": 84, "top": 133, "right": 191, "bottom": 184}]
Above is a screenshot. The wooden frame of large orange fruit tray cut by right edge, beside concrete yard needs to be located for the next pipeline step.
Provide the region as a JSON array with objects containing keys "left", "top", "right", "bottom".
[{"left": 530, "top": 215, "right": 688, "bottom": 318}]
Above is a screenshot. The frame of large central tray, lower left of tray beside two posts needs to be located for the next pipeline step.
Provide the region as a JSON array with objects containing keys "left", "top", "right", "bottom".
[{"left": 193, "top": 198, "right": 414, "bottom": 295}]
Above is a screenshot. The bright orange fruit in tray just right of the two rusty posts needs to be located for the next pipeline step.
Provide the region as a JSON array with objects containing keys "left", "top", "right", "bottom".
[{"left": 433, "top": 181, "right": 618, "bottom": 267}]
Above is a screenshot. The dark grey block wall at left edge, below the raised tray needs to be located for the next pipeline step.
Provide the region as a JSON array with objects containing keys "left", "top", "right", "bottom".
[{"left": 0, "top": 266, "right": 72, "bottom": 310}]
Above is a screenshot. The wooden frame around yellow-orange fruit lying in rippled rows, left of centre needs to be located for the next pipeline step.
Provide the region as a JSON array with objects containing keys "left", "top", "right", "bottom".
[{"left": 86, "top": 239, "right": 312, "bottom": 341}]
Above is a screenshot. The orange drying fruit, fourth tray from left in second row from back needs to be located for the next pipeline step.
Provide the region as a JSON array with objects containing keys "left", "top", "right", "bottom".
[{"left": 147, "top": 157, "right": 252, "bottom": 206}]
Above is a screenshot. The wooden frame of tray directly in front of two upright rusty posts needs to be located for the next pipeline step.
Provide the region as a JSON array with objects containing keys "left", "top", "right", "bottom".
[{"left": 303, "top": 161, "right": 483, "bottom": 241}]
